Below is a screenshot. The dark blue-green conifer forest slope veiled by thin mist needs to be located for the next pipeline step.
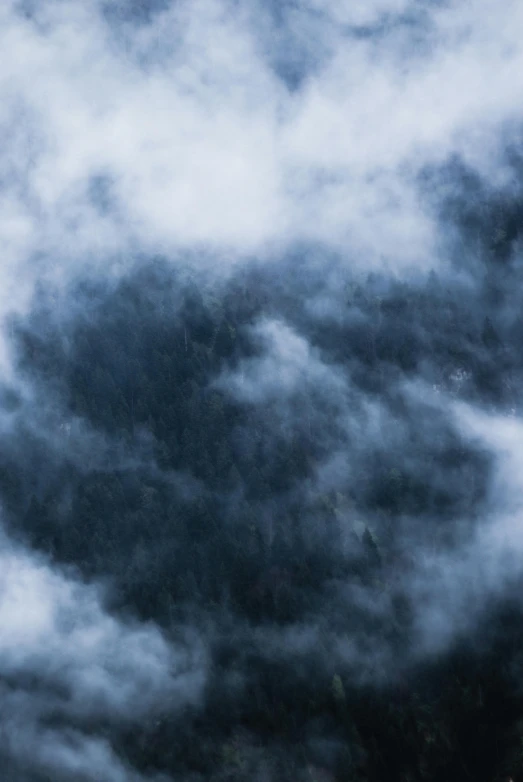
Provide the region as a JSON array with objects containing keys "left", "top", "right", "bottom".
[{"left": 0, "top": 161, "right": 523, "bottom": 782}]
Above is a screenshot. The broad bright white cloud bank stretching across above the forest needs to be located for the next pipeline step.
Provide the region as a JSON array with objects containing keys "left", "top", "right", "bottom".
[{"left": 0, "top": 0, "right": 523, "bottom": 322}]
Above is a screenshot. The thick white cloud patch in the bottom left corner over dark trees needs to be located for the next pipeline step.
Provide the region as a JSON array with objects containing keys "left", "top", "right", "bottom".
[{"left": 0, "top": 536, "right": 206, "bottom": 782}]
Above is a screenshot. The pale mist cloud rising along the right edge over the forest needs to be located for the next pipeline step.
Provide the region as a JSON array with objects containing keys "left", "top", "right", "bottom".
[{"left": 404, "top": 403, "right": 523, "bottom": 656}]
